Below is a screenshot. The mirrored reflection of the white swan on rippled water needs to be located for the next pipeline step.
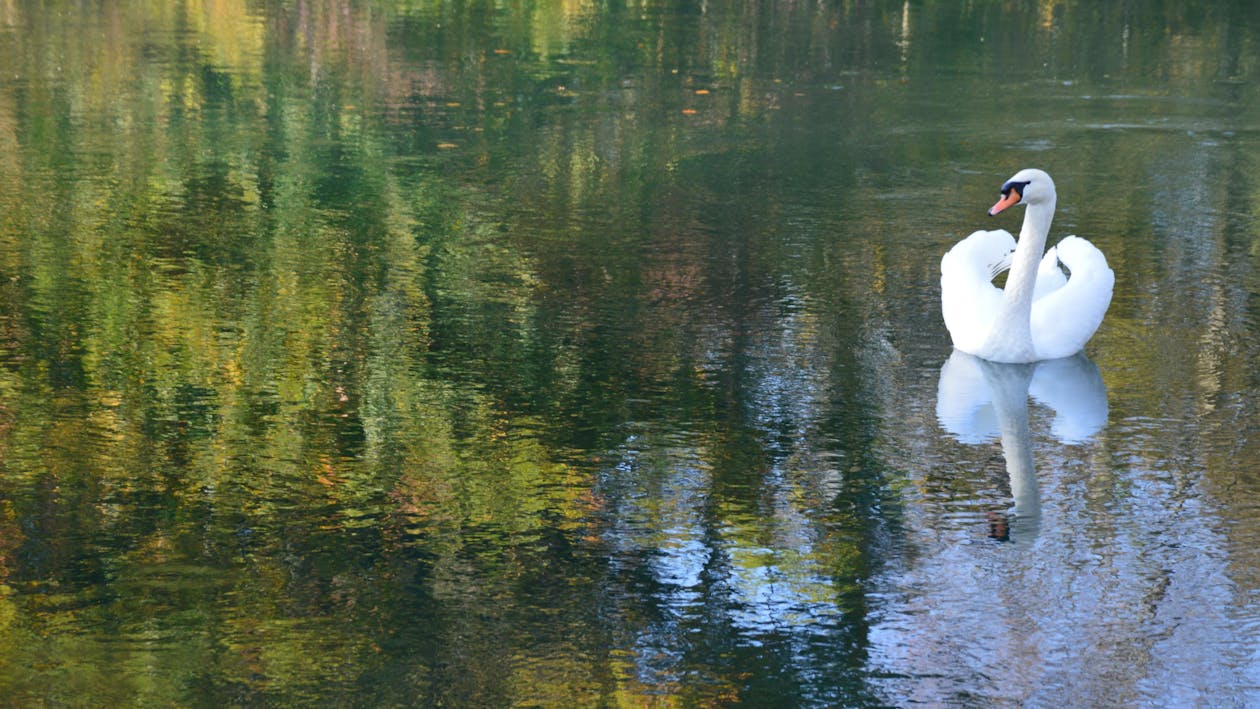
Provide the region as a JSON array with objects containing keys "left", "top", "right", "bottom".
[{"left": 936, "top": 350, "right": 1108, "bottom": 539}]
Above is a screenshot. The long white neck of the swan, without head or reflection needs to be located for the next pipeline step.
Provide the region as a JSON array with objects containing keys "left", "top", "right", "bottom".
[{"left": 989, "top": 196, "right": 1055, "bottom": 361}]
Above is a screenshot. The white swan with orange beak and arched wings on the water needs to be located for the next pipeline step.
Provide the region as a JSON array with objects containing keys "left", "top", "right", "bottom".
[{"left": 941, "top": 169, "right": 1115, "bottom": 363}]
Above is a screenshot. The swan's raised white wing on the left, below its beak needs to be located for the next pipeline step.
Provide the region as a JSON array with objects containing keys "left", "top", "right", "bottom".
[{"left": 941, "top": 229, "right": 1016, "bottom": 351}]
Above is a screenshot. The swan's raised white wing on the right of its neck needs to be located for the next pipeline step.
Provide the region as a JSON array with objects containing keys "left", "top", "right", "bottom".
[{"left": 1032, "top": 237, "right": 1115, "bottom": 359}]
